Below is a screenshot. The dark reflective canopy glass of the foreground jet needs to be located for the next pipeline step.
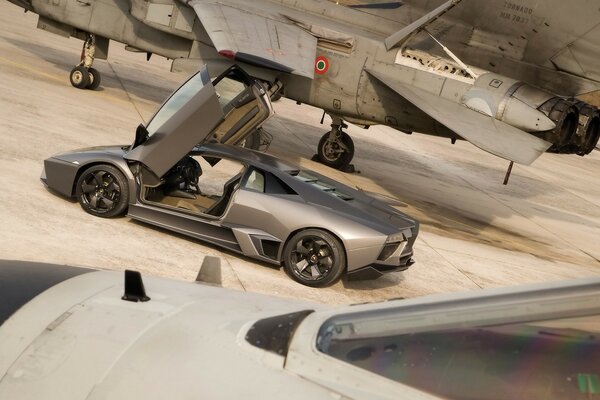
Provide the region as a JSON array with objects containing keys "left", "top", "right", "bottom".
[{"left": 317, "top": 315, "right": 600, "bottom": 400}]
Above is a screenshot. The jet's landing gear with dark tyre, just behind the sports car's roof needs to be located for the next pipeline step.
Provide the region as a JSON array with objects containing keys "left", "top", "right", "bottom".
[{"left": 317, "top": 117, "right": 354, "bottom": 172}]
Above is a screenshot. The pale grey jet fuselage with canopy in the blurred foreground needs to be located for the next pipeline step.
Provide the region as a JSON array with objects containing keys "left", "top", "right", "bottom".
[{"left": 0, "top": 261, "right": 600, "bottom": 400}]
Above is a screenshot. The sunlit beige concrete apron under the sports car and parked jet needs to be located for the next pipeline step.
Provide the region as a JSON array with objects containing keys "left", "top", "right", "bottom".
[{"left": 0, "top": 2, "right": 600, "bottom": 303}]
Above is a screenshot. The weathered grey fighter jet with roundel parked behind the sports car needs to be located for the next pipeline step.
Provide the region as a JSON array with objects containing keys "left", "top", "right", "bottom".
[{"left": 5, "top": 0, "right": 600, "bottom": 177}]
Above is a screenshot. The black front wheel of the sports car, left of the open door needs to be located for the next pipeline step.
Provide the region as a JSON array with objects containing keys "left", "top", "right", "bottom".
[{"left": 75, "top": 164, "right": 129, "bottom": 218}]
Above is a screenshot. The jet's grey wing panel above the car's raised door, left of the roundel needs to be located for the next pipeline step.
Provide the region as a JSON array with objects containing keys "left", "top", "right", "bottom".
[{"left": 184, "top": 0, "right": 317, "bottom": 78}]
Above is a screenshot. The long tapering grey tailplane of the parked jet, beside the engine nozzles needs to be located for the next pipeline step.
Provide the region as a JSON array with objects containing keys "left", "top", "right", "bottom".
[{"left": 367, "top": 70, "right": 552, "bottom": 165}]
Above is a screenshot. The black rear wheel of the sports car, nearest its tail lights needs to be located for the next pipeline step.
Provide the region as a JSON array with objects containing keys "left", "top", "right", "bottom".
[{"left": 283, "top": 229, "right": 346, "bottom": 287}]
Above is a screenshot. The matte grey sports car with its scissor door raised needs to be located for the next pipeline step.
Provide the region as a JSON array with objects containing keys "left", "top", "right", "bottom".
[{"left": 41, "top": 67, "right": 419, "bottom": 286}]
